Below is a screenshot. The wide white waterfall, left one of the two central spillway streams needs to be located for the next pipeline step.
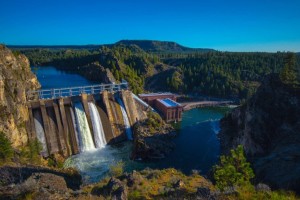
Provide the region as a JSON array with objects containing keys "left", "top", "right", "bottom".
[{"left": 75, "top": 103, "right": 95, "bottom": 152}]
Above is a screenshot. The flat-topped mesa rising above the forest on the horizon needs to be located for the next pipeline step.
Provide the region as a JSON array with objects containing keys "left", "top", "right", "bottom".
[{"left": 116, "top": 40, "right": 215, "bottom": 53}]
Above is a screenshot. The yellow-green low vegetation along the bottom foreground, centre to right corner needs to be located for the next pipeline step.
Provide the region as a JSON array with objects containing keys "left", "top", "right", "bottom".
[{"left": 89, "top": 168, "right": 297, "bottom": 200}]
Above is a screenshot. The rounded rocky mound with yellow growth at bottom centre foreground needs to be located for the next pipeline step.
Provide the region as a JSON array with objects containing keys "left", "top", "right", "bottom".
[{"left": 90, "top": 169, "right": 217, "bottom": 200}]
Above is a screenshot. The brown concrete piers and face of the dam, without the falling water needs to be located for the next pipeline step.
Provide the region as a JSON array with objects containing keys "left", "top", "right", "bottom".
[{"left": 26, "top": 91, "right": 139, "bottom": 157}]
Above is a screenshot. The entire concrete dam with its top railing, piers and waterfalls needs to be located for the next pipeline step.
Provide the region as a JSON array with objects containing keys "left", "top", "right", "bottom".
[{"left": 26, "top": 83, "right": 149, "bottom": 157}]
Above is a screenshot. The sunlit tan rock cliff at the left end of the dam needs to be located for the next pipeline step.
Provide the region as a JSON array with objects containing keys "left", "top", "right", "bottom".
[{"left": 0, "top": 45, "right": 40, "bottom": 147}]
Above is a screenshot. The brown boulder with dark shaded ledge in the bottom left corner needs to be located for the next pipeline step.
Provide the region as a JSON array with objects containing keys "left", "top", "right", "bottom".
[{"left": 0, "top": 166, "right": 82, "bottom": 199}]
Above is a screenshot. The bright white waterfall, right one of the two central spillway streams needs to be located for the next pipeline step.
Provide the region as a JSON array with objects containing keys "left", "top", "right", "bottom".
[{"left": 88, "top": 102, "right": 106, "bottom": 148}]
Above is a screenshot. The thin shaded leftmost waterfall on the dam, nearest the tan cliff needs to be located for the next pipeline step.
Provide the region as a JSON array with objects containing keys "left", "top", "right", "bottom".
[{"left": 33, "top": 110, "right": 49, "bottom": 157}]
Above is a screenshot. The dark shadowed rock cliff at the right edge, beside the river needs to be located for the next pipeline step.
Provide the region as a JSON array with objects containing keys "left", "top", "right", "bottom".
[{"left": 219, "top": 74, "right": 300, "bottom": 192}]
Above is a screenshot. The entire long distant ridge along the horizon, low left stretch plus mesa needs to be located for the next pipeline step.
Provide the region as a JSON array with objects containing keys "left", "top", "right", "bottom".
[{"left": 7, "top": 40, "right": 215, "bottom": 53}]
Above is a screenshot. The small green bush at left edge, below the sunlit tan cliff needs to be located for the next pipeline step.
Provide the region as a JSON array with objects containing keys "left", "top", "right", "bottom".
[{"left": 0, "top": 132, "right": 14, "bottom": 165}]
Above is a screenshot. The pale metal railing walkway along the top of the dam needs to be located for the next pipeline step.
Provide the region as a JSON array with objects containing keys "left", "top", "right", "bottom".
[{"left": 26, "top": 80, "right": 128, "bottom": 101}]
